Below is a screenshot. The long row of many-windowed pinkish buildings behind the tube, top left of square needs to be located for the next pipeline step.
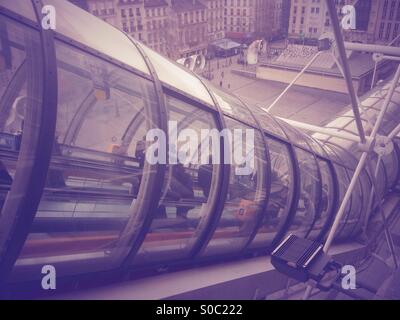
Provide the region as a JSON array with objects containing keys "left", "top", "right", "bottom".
[{"left": 79, "top": 0, "right": 278, "bottom": 59}]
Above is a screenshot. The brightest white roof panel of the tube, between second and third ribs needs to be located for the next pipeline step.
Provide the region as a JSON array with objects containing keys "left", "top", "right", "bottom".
[{"left": 140, "top": 44, "right": 214, "bottom": 106}]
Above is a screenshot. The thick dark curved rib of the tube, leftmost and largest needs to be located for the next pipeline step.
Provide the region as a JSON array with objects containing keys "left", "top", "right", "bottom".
[{"left": 0, "top": 0, "right": 58, "bottom": 285}]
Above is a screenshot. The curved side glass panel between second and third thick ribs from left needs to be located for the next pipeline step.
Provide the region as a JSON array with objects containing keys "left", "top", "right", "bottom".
[{"left": 134, "top": 96, "right": 223, "bottom": 264}]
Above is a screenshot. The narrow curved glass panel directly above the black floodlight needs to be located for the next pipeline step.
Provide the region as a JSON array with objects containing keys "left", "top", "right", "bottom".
[{"left": 290, "top": 148, "right": 321, "bottom": 236}]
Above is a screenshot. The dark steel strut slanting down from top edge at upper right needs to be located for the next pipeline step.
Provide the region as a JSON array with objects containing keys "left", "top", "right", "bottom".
[{"left": 326, "top": 0, "right": 366, "bottom": 144}]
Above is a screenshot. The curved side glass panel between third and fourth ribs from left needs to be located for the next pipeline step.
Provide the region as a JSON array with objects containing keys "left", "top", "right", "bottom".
[{"left": 202, "top": 118, "right": 269, "bottom": 256}]
